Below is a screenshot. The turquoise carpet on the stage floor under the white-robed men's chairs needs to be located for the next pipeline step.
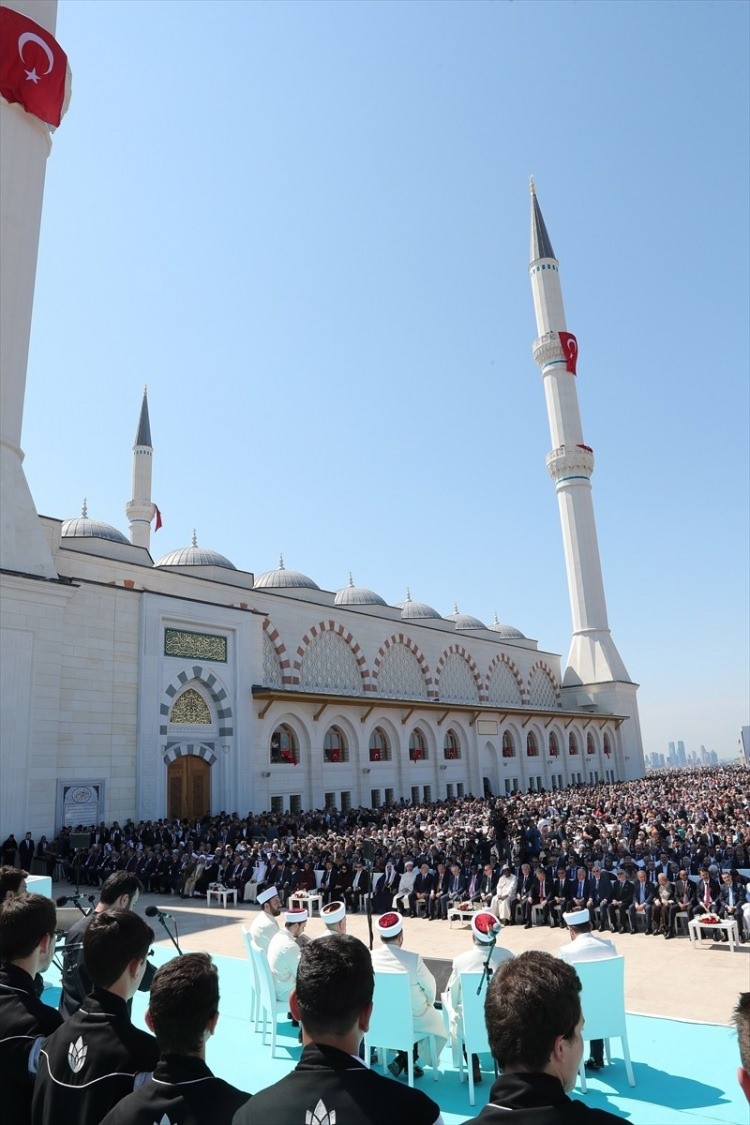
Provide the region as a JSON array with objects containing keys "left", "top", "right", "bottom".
[{"left": 45, "top": 946, "right": 750, "bottom": 1125}]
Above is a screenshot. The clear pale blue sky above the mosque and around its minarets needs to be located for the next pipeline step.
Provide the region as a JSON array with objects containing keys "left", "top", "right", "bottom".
[{"left": 24, "top": 0, "right": 749, "bottom": 757}]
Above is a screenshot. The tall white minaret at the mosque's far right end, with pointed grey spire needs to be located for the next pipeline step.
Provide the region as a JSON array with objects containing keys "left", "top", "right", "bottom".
[{"left": 528, "top": 181, "right": 631, "bottom": 687}]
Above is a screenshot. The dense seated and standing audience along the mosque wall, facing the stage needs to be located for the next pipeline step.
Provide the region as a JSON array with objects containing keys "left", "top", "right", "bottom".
[{"left": 1, "top": 767, "right": 750, "bottom": 941}]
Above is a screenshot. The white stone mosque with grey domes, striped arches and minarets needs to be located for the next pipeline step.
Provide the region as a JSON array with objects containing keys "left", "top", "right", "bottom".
[{"left": 0, "top": 0, "right": 644, "bottom": 836}]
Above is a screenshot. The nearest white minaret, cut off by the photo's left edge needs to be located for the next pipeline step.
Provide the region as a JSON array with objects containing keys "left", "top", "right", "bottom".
[{"left": 0, "top": 0, "right": 57, "bottom": 578}]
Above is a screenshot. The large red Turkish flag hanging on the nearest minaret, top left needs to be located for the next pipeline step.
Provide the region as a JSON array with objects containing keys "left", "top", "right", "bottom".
[{"left": 0, "top": 7, "right": 69, "bottom": 126}]
